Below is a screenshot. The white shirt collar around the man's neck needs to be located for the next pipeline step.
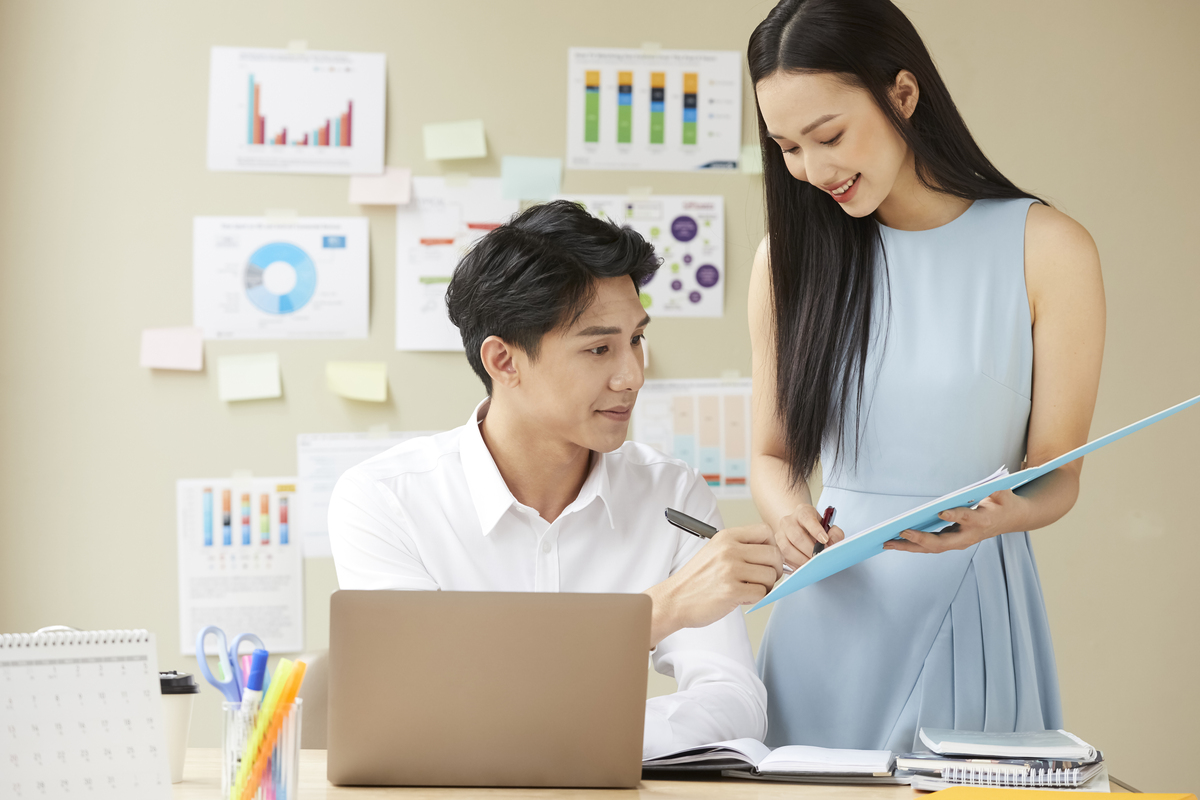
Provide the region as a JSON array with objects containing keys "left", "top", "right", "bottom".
[{"left": 458, "top": 397, "right": 617, "bottom": 536}]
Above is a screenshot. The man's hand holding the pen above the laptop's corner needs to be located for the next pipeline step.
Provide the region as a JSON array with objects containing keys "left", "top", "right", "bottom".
[{"left": 646, "top": 524, "right": 784, "bottom": 648}]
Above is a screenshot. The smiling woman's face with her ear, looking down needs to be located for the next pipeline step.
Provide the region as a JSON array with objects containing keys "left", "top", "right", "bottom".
[{"left": 755, "top": 71, "right": 917, "bottom": 217}]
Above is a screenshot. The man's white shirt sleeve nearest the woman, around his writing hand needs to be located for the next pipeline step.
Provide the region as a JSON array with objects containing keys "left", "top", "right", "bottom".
[{"left": 642, "top": 470, "right": 767, "bottom": 758}]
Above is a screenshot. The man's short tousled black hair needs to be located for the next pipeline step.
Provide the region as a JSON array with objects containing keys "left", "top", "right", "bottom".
[{"left": 446, "top": 200, "right": 660, "bottom": 395}]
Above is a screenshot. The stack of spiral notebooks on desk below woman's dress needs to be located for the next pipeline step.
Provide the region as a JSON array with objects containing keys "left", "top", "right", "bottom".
[{"left": 896, "top": 728, "right": 1109, "bottom": 792}]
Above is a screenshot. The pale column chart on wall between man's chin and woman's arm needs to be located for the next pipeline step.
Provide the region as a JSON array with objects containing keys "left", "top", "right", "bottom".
[{"left": 634, "top": 378, "right": 751, "bottom": 498}]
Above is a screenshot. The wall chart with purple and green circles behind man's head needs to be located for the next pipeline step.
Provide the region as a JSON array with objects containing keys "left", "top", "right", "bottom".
[{"left": 566, "top": 194, "right": 725, "bottom": 317}]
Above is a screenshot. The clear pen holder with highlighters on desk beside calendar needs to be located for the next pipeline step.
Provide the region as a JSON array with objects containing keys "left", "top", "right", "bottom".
[{"left": 221, "top": 699, "right": 304, "bottom": 800}]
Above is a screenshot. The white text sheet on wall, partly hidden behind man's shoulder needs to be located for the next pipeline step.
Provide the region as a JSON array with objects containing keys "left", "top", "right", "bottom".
[{"left": 295, "top": 431, "right": 434, "bottom": 558}]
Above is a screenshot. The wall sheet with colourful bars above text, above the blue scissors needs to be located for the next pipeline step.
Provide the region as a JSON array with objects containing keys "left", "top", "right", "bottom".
[{"left": 175, "top": 477, "right": 304, "bottom": 655}]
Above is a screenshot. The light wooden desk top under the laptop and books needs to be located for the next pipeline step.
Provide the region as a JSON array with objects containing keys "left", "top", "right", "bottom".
[{"left": 172, "top": 747, "right": 920, "bottom": 800}]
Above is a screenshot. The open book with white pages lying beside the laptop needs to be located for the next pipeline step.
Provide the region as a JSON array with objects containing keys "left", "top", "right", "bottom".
[{"left": 642, "top": 739, "right": 895, "bottom": 776}]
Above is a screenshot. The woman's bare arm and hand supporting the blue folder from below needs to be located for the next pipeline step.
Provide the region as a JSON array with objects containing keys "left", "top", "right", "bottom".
[{"left": 884, "top": 203, "right": 1105, "bottom": 553}]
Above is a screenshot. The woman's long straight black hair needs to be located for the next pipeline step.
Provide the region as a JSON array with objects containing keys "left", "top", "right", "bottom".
[{"left": 748, "top": 0, "right": 1038, "bottom": 483}]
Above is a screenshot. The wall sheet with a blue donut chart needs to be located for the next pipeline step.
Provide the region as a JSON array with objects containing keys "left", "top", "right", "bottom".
[{"left": 192, "top": 217, "right": 370, "bottom": 339}]
